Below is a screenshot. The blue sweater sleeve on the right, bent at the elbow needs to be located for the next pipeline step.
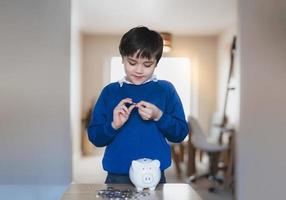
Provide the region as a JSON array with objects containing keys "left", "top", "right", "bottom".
[{"left": 157, "top": 83, "right": 189, "bottom": 143}]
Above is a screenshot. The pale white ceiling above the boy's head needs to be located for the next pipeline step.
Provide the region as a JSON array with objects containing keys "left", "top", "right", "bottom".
[{"left": 74, "top": 0, "right": 237, "bottom": 36}]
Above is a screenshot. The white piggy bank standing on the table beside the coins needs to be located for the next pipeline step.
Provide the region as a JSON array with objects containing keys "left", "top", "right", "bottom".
[{"left": 129, "top": 158, "right": 161, "bottom": 191}]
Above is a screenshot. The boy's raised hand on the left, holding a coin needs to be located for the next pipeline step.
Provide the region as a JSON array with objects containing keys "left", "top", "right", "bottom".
[{"left": 111, "top": 98, "right": 135, "bottom": 129}]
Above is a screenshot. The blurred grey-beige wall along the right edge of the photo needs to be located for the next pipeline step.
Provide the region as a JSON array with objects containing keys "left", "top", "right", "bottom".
[{"left": 236, "top": 0, "right": 286, "bottom": 200}]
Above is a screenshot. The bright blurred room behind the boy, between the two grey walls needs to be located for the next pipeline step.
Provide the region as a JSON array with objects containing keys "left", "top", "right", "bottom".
[{"left": 71, "top": 1, "right": 239, "bottom": 199}]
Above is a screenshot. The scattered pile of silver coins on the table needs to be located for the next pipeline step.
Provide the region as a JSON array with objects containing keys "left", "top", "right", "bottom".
[{"left": 97, "top": 187, "right": 150, "bottom": 200}]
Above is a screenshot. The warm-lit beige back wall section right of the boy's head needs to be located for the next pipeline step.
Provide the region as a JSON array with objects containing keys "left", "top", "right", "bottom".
[{"left": 167, "top": 36, "right": 218, "bottom": 133}]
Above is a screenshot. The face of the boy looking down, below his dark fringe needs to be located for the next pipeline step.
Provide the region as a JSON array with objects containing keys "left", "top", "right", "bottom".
[{"left": 122, "top": 54, "right": 156, "bottom": 85}]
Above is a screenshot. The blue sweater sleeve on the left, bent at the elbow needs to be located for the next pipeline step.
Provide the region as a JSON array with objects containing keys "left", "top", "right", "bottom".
[{"left": 88, "top": 88, "right": 118, "bottom": 147}]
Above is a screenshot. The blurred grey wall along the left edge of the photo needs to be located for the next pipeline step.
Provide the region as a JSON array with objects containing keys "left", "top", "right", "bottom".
[{"left": 0, "top": 0, "right": 71, "bottom": 199}]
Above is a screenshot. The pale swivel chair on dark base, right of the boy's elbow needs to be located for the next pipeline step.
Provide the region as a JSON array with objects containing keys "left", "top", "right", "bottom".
[{"left": 189, "top": 117, "right": 228, "bottom": 192}]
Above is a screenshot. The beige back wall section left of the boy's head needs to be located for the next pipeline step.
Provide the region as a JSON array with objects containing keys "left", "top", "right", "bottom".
[{"left": 82, "top": 34, "right": 120, "bottom": 113}]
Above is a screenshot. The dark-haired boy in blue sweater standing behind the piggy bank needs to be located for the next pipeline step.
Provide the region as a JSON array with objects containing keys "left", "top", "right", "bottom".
[{"left": 88, "top": 27, "right": 189, "bottom": 183}]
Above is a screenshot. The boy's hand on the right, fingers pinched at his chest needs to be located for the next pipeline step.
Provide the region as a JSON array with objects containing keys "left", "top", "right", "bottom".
[{"left": 136, "top": 101, "right": 163, "bottom": 121}]
